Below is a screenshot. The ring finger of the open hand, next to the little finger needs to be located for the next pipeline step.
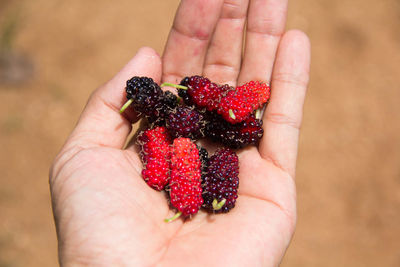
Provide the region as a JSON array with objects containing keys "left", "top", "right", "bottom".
[{"left": 239, "top": 0, "right": 287, "bottom": 84}]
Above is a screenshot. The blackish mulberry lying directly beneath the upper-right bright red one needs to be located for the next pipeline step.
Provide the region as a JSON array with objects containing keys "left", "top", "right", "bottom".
[{"left": 205, "top": 113, "right": 264, "bottom": 148}]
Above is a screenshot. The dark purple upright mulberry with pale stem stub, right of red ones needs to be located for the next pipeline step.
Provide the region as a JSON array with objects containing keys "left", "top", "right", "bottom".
[{"left": 202, "top": 148, "right": 239, "bottom": 213}]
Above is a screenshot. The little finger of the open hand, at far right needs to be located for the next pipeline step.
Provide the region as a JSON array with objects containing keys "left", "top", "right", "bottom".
[{"left": 259, "top": 30, "right": 310, "bottom": 177}]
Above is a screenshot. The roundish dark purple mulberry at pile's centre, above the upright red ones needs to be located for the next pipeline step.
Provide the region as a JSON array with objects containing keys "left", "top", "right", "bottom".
[{"left": 165, "top": 106, "right": 205, "bottom": 140}]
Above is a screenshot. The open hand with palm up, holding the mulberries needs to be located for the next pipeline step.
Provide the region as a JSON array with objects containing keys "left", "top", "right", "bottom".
[{"left": 50, "top": 0, "right": 310, "bottom": 266}]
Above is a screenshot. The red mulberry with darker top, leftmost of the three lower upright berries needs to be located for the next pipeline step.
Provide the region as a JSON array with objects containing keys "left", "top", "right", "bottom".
[{"left": 137, "top": 127, "right": 171, "bottom": 191}]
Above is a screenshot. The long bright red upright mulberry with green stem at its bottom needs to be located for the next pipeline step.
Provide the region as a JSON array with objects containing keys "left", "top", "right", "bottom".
[{"left": 166, "top": 138, "right": 203, "bottom": 222}]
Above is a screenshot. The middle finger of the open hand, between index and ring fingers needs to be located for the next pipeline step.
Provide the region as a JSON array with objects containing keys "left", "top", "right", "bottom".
[{"left": 203, "top": 0, "right": 249, "bottom": 86}]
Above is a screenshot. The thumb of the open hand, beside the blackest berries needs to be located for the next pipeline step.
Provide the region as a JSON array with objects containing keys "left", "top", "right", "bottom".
[{"left": 67, "top": 47, "right": 161, "bottom": 151}]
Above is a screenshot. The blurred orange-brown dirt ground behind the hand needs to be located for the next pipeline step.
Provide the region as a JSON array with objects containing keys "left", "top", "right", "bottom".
[{"left": 0, "top": 0, "right": 400, "bottom": 267}]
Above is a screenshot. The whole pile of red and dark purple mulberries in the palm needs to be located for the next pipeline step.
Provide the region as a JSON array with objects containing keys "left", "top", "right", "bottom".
[{"left": 120, "top": 76, "right": 270, "bottom": 222}]
